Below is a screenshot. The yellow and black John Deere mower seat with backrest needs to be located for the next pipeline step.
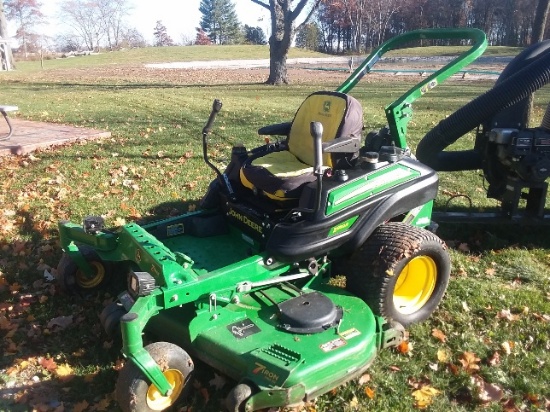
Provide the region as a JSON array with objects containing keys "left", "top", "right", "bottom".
[{"left": 240, "top": 91, "right": 363, "bottom": 201}]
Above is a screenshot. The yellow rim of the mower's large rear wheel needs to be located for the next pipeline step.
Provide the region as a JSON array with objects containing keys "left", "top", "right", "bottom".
[{"left": 393, "top": 256, "right": 437, "bottom": 315}]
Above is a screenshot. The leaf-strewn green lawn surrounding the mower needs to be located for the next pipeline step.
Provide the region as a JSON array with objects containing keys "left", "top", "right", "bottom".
[{"left": 0, "top": 47, "right": 550, "bottom": 412}]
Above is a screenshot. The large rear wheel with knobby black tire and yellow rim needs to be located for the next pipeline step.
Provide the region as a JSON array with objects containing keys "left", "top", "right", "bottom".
[{"left": 340, "top": 222, "right": 451, "bottom": 326}]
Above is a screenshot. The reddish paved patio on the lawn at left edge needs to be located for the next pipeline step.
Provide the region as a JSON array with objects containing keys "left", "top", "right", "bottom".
[{"left": 0, "top": 117, "right": 111, "bottom": 156}]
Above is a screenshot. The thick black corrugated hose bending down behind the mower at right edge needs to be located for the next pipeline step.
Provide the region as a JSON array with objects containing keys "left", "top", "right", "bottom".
[{"left": 416, "top": 43, "right": 550, "bottom": 171}]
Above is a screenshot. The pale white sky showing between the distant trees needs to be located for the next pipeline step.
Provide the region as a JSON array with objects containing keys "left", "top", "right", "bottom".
[{"left": 34, "top": 0, "right": 269, "bottom": 43}]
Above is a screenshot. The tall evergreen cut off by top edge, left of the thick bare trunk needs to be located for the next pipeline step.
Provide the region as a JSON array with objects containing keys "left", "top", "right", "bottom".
[{"left": 199, "top": 0, "right": 242, "bottom": 44}]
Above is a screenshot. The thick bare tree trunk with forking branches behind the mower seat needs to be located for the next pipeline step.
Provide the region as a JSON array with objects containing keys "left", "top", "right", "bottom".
[{"left": 250, "top": 0, "right": 321, "bottom": 84}]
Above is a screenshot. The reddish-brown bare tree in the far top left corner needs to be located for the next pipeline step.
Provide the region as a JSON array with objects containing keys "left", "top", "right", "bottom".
[{"left": 4, "top": 0, "right": 44, "bottom": 57}]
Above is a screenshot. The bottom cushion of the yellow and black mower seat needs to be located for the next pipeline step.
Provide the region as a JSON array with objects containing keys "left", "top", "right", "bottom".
[{"left": 240, "top": 150, "right": 315, "bottom": 201}]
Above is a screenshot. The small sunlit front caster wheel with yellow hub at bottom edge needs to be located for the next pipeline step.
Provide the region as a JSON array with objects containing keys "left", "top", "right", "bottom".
[{"left": 116, "top": 342, "right": 194, "bottom": 412}]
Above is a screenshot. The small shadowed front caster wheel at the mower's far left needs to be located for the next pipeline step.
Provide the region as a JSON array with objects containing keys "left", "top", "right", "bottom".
[{"left": 55, "top": 246, "right": 113, "bottom": 294}]
